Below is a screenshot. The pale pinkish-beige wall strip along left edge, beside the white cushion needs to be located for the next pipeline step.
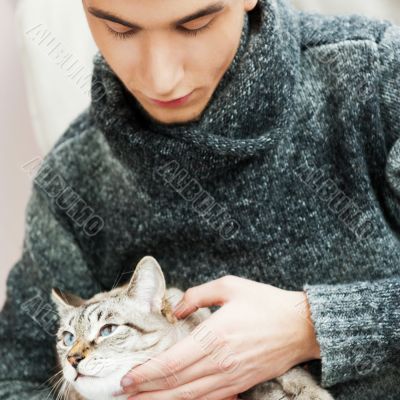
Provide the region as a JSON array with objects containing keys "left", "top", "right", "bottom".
[{"left": 0, "top": 0, "right": 40, "bottom": 307}]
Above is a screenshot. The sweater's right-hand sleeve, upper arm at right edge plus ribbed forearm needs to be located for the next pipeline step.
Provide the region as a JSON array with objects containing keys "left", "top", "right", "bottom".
[{"left": 303, "top": 21, "right": 400, "bottom": 387}]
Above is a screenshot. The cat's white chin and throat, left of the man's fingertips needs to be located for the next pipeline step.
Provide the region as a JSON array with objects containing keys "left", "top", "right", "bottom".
[{"left": 65, "top": 368, "right": 130, "bottom": 400}]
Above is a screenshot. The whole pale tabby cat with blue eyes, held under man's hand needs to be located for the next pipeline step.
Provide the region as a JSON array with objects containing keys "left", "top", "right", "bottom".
[{"left": 53, "top": 256, "right": 333, "bottom": 400}]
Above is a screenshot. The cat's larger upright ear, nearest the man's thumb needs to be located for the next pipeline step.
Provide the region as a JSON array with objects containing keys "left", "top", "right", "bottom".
[{"left": 127, "top": 256, "right": 165, "bottom": 313}]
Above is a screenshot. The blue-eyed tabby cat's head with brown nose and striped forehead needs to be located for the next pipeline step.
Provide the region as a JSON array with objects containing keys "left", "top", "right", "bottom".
[{"left": 52, "top": 256, "right": 179, "bottom": 400}]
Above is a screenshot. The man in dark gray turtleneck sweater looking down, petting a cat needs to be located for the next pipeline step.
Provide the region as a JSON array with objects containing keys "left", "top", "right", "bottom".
[{"left": 0, "top": 0, "right": 400, "bottom": 400}]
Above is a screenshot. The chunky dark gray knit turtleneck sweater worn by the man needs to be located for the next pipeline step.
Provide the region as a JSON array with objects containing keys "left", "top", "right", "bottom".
[{"left": 0, "top": 0, "right": 400, "bottom": 400}]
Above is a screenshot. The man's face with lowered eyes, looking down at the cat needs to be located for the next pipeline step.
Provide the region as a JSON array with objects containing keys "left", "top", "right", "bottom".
[{"left": 83, "top": 0, "right": 257, "bottom": 124}]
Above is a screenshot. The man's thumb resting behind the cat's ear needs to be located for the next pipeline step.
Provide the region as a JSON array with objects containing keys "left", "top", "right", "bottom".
[{"left": 174, "top": 276, "right": 233, "bottom": 318}]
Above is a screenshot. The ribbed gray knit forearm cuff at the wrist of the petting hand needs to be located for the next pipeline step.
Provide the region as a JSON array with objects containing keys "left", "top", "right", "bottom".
[{"left": 303, "top": 278, "right": 400, "bottom": 387}]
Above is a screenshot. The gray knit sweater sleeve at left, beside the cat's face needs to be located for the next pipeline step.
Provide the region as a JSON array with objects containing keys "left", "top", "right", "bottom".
[{"left": 0, "top": 164, "right": 104, "bottom": 400}]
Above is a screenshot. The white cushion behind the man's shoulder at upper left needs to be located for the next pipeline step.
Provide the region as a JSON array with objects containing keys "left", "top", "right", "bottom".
[{"left": 16, "top": 0, "right": 96, "bottom": 153}]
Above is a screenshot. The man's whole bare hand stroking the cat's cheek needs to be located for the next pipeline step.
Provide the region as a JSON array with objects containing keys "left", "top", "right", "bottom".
[{"left": 117, "top": 275, "right": 320, "bottom": 400}]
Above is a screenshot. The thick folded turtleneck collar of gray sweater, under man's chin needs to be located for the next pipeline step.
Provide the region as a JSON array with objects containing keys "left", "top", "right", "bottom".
[{"left": 90, "top": 0, "right": 300, "bottom": 176}]
